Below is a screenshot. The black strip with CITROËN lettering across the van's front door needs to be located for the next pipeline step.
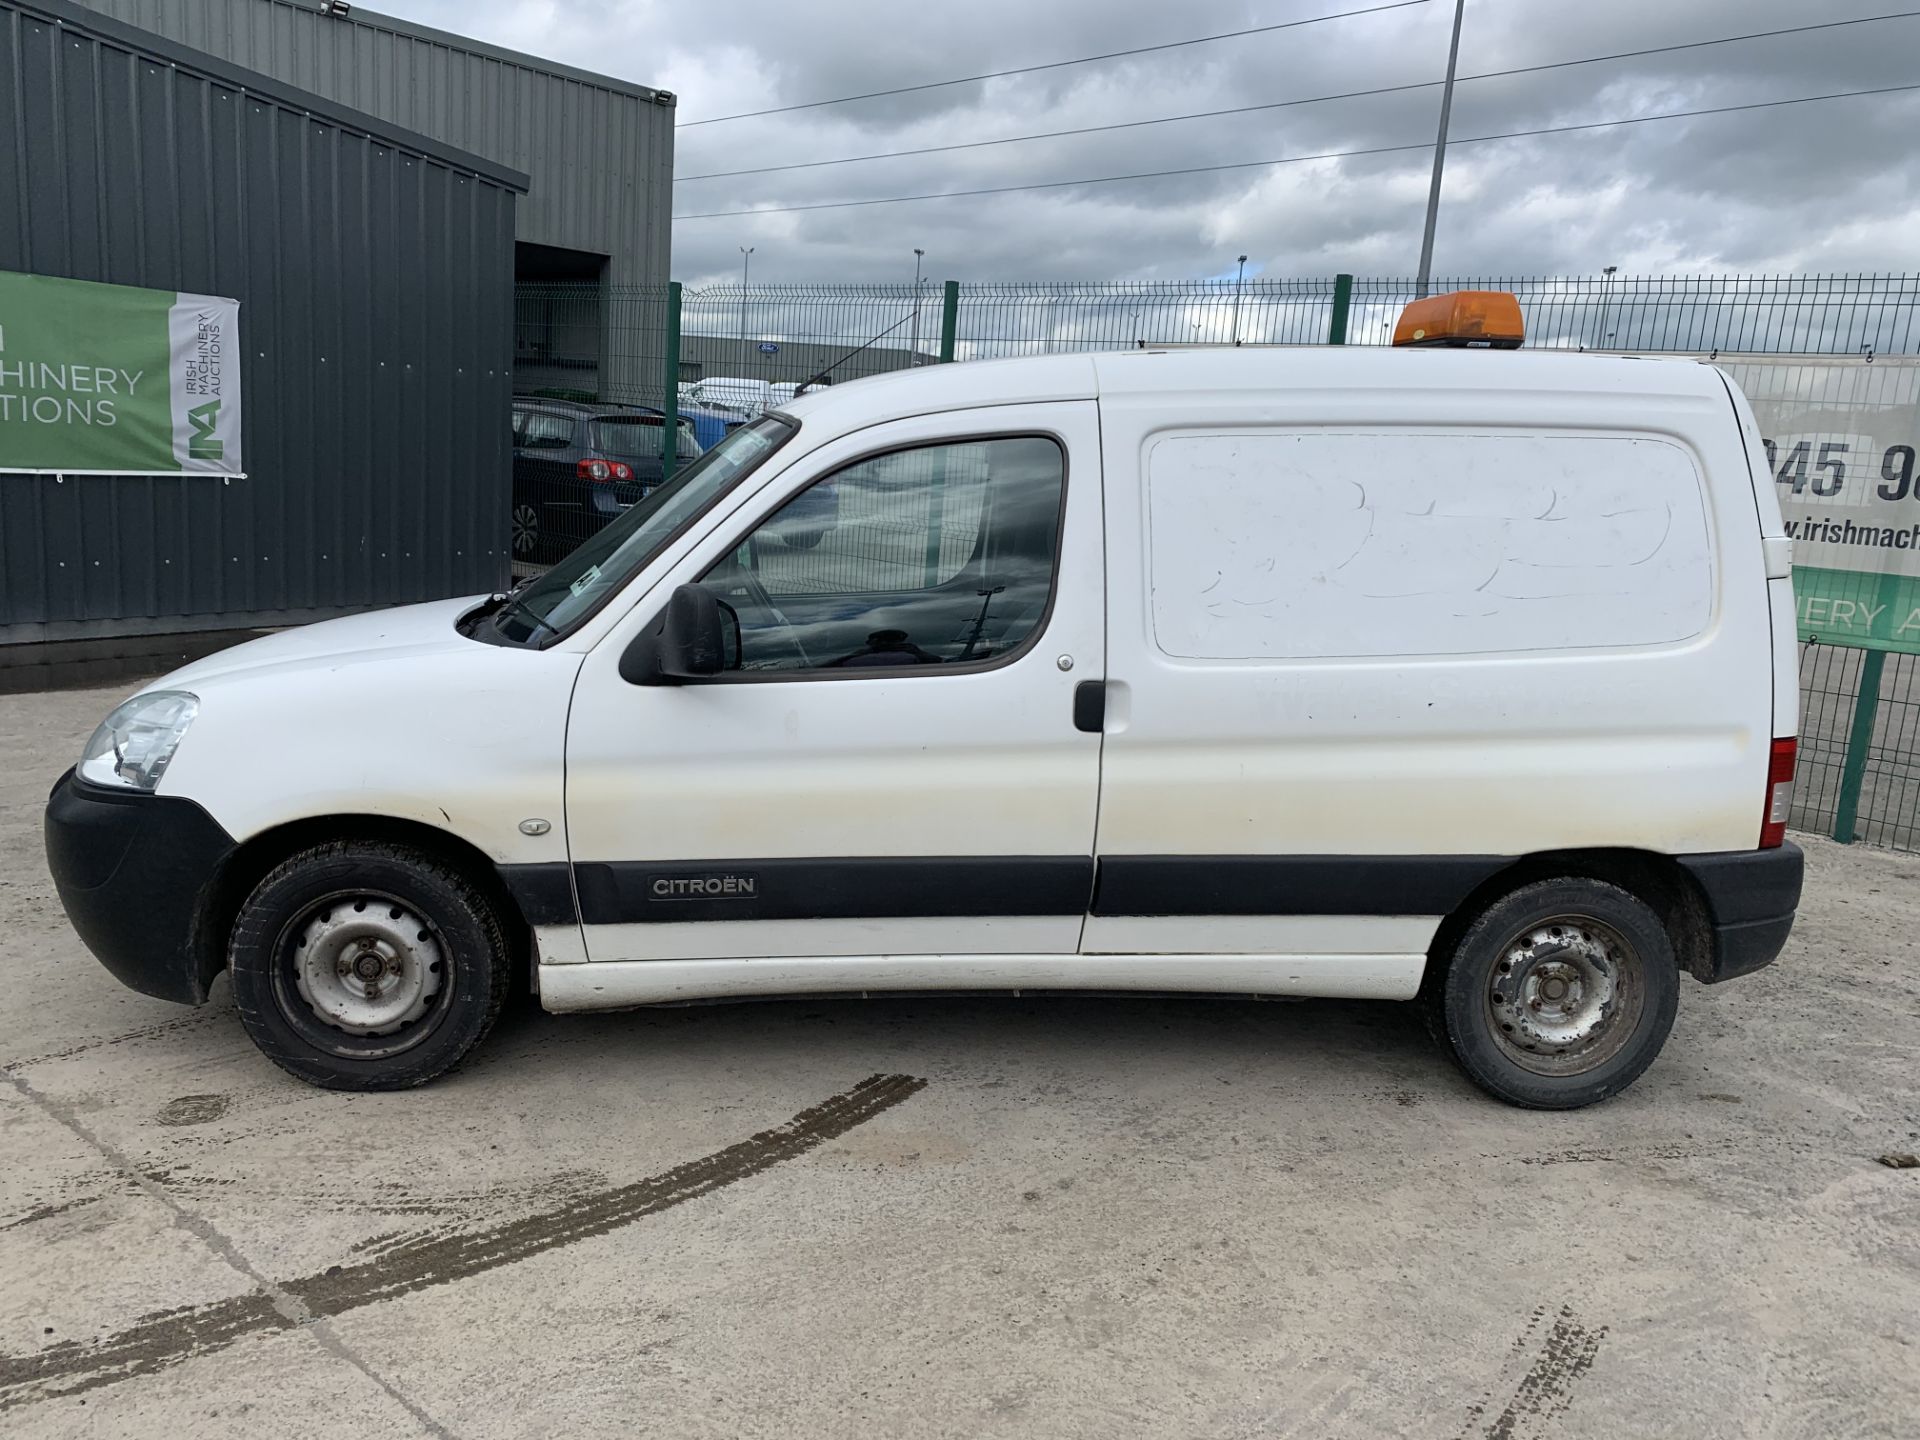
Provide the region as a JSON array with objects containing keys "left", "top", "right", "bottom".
[{"left": 574, "top": 854, "right": 1092, "bottom": 925}]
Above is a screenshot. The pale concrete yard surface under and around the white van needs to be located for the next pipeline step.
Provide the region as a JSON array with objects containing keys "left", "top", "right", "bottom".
[{"left": 0, "top": 691, "right": 1920, "bottom": 1440}]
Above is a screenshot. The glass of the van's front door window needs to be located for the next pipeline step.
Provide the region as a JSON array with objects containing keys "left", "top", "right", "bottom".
[{"left": 701, "top": 436, "right": 1066, "bottom": 672}]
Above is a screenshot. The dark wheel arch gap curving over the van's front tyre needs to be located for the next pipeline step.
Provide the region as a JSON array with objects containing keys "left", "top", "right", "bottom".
[{"left": 196, "top": 814, "right": 534, "bottom": 995}]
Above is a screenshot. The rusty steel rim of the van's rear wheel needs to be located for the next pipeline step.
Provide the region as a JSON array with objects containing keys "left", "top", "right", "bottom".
[{"left": 1482, "top": 914, "right": 1647, "bottom": 1075}]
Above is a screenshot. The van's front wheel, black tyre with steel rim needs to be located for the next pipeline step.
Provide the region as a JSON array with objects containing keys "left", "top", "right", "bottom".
[{"left": 227, "top": 841, "right": 513, "bottom": 1091}]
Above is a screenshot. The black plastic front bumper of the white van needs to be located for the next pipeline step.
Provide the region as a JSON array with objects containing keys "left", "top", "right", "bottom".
[{"left": 46, "top": 770, "right": 234, "bottom": 1004}]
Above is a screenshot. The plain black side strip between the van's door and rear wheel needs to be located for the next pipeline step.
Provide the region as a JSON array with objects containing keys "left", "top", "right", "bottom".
[{"left": 1092, "top": 854, "right": 1513, "bottom": 916}]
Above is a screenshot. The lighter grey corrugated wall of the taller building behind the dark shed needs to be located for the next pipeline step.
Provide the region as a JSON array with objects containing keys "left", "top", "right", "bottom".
[{"left": 84, "top": 0, "right": 674, "bottom": 284}]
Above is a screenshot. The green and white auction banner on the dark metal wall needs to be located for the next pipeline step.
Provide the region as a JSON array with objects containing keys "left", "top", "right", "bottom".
[{"left": 0, "top": 271, "right": 246, "bottom": 476}]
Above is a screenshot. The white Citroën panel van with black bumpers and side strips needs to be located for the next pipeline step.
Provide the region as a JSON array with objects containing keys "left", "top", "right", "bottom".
[{"left": 46, "top": 289, "right": 1801, "bottom": 1108}]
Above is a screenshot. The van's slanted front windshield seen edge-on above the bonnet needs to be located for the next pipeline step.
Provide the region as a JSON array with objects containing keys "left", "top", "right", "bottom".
[{"left": 493, "top": 415, "right": 799, "bottom": 645}]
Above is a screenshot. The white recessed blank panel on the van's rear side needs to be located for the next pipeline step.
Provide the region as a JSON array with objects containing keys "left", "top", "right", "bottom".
[{"left": 1146, "top": 430, "right": 1716, "bottom": 660}]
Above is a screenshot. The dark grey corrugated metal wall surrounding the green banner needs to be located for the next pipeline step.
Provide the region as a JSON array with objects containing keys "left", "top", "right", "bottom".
[{"left": 0, "top": 0, "right": 526, "bottom": 643}]
